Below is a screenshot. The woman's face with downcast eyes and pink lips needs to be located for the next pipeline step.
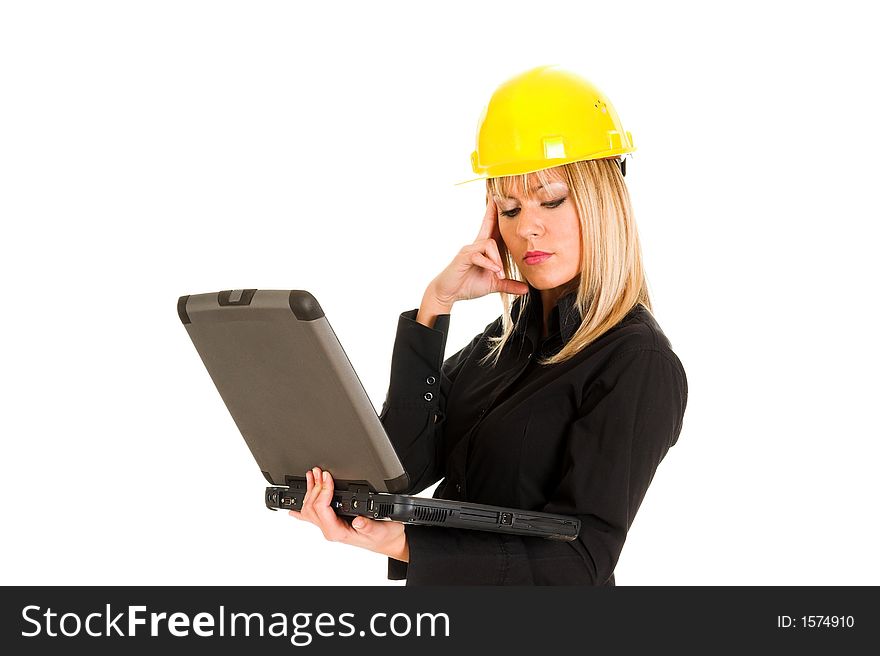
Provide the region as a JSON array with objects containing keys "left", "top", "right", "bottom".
[{"left": 495, "top": 179, "right": 583, "bottom": 290}]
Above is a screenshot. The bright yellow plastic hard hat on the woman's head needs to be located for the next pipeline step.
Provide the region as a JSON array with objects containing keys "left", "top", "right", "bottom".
[{"left": 455, "top": 65, "right": 635, "bottom": 185}]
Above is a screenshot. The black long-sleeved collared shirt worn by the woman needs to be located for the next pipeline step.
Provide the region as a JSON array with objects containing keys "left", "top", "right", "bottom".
[{"left": 380, "top": 285, "right": 688, "bottom": 585}]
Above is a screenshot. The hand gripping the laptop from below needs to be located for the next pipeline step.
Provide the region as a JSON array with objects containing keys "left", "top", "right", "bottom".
[{"left": 289, "top": 467, "right": 409, "bottom": 562}]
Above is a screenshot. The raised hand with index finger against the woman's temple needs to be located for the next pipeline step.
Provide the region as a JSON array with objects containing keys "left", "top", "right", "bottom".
[{"left": 431, "top": 192, "right": 529, "bottom": 307}]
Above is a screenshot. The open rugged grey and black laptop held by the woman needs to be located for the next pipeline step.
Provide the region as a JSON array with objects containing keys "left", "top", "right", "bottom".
[{"left": 177, "top": 289, "right": 580, "bottom": 540}]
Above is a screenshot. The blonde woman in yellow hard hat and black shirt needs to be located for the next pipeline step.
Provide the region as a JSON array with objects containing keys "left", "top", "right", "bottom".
[{"left": 291, "top": 67, "right": 687, "bottom": 586}]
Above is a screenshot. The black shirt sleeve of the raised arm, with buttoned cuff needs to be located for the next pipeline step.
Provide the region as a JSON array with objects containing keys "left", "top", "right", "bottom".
[{"left": 379, "top": 308, "right": 492, "bottom": 580}]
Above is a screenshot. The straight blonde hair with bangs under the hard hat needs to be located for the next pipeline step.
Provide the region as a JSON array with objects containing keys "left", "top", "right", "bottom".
[{"left": 480, "top": 159, "right": 653, "bottom": 366}]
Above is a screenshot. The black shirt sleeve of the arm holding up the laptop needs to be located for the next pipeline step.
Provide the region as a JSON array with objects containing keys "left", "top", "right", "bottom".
[{"left": 389, "top": 348, "right": 687, "bottom": 585}]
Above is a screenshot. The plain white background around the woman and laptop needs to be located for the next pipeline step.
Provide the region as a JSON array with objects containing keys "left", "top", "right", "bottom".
[{"left": 0, "top": 0, "right": 880, "bottom": 585}]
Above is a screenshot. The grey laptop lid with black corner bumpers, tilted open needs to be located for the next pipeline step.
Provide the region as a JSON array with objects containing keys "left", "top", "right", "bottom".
[{"left": 177, "top": 289, "right": 409, "bottom": 493}]
